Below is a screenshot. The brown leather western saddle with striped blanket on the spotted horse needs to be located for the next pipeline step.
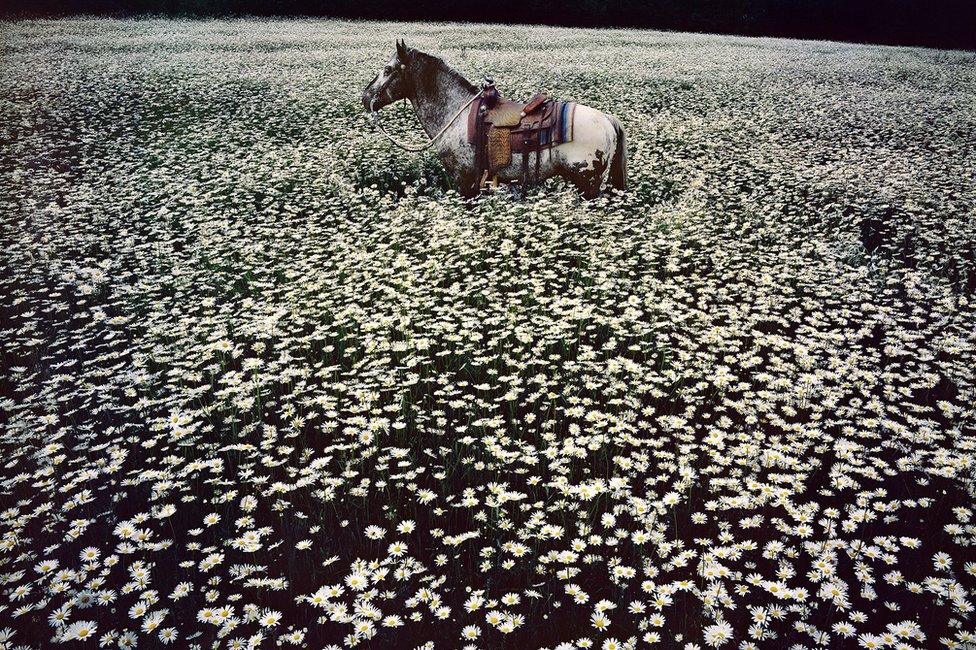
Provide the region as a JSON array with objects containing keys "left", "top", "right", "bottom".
[{"left": 468, "top": 82, "right": 576, "bottom": 189}]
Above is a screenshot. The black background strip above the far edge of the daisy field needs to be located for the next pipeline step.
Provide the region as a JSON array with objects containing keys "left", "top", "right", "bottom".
[{"left": 0, "top": 0, "right": 976, "bottom": 49}]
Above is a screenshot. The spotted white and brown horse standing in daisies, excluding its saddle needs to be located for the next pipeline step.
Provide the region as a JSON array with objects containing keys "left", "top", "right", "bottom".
[{"left": 362, "top": 40, "right": 627, "bottom": 199}]
